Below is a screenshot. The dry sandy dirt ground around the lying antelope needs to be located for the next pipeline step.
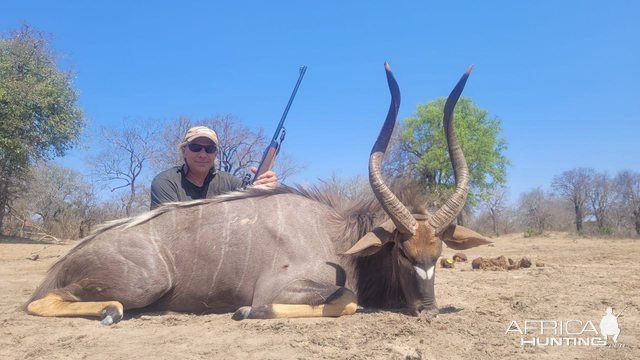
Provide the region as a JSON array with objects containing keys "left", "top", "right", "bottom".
[{"left": 0, "top": 234, "right": 640, "bottom": 359}]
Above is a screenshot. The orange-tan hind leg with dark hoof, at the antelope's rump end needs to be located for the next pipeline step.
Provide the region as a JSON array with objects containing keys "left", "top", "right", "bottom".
[{"left": 27, "top": 293, "right": 124, "bottom": 325}]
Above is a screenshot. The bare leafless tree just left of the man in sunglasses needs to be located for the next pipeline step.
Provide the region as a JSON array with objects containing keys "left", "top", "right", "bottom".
[{"left": 92, "top": 122, "right": 157, "bottom": 216}]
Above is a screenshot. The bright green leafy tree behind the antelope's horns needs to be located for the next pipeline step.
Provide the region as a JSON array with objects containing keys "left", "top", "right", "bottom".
[{"left": 390, "top": 97, "right": 509, "bottom": 211}]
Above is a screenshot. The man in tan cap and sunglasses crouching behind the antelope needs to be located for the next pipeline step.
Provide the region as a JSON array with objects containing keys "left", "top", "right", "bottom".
[{"left": 151, "top": 126, "right": 278, "bottom": 210}]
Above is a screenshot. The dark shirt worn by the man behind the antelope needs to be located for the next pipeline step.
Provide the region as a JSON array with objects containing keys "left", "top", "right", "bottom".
[{"left": 151, "top": 166, "right": 242, "bottom": 210}]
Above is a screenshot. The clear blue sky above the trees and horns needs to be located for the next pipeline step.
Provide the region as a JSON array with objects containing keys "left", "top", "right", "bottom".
[{"left": 0, "top": 0, "right": 640, "bottom": 198}]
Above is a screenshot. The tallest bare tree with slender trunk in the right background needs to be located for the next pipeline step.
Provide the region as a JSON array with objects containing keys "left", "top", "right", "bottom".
[{"left": 551, "top": 168, "right": 595, "bottom": 233}]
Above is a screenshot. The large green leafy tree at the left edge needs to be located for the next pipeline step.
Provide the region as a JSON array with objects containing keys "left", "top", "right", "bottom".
[{"left": 0, "top": 25, "right": 84, "bottom": 231}]
